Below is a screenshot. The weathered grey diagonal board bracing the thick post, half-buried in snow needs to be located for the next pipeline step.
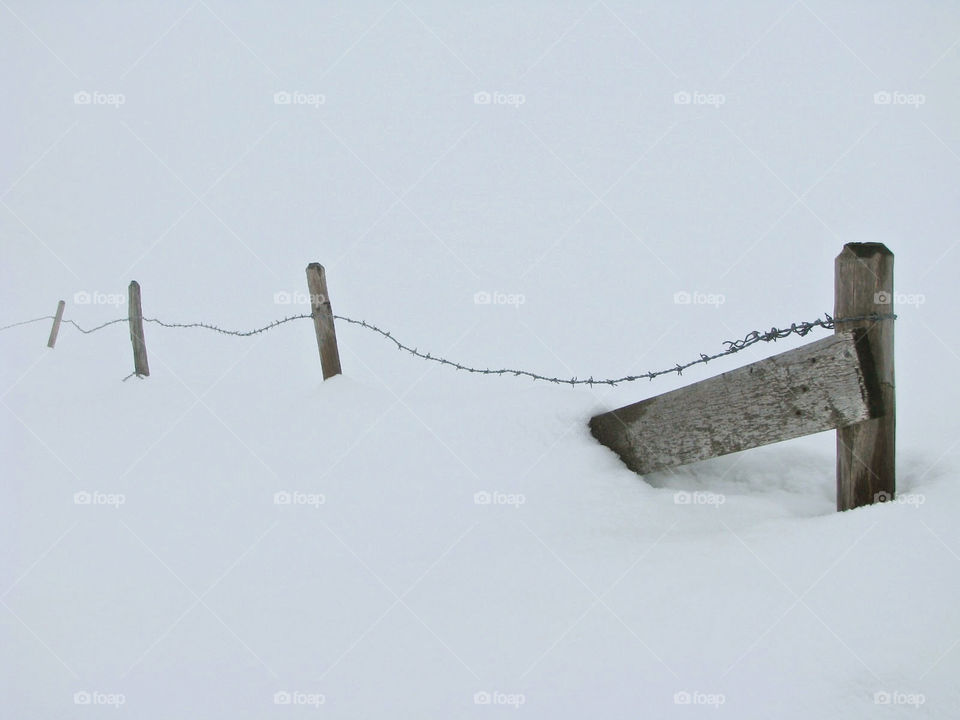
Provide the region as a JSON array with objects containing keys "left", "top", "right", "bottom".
[{"left": 590, "top": 331, "right": 883, "bottom": 474}]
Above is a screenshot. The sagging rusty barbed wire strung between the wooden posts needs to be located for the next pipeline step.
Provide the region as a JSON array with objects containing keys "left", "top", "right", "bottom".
[{"left": 0, "top": 313, "right": 897, "bottom": 387}]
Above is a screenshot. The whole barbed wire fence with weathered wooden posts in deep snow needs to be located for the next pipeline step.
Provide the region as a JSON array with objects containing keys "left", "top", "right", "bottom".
[{"left": 0, "top": 248, "right": 897, "bottom": 510}]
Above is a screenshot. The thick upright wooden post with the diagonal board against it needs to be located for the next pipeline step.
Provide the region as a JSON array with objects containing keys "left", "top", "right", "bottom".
[{"left": 834, "top": 243, "right": 896, "bottom": 510}]
